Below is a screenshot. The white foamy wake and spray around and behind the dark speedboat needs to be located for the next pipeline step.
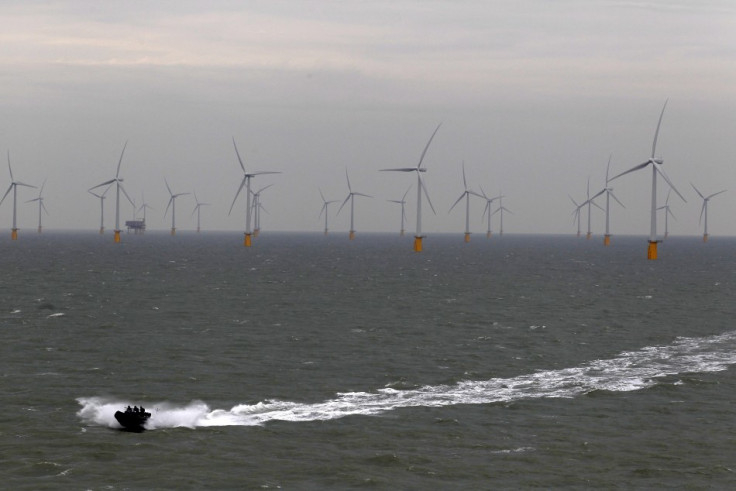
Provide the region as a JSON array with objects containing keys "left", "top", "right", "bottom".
[{"left": 77, "top": 331, "right": 736, "bottom": 429}]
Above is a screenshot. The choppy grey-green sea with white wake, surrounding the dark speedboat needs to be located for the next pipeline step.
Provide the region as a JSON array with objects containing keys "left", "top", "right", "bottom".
[{"left": 0, "top": 231, "right": 736, "bottom": 490}]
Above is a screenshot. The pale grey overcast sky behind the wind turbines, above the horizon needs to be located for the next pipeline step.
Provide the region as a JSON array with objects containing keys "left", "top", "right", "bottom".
[{"left": 0, "top": 0, "right": 736, "bottom": 236}]
